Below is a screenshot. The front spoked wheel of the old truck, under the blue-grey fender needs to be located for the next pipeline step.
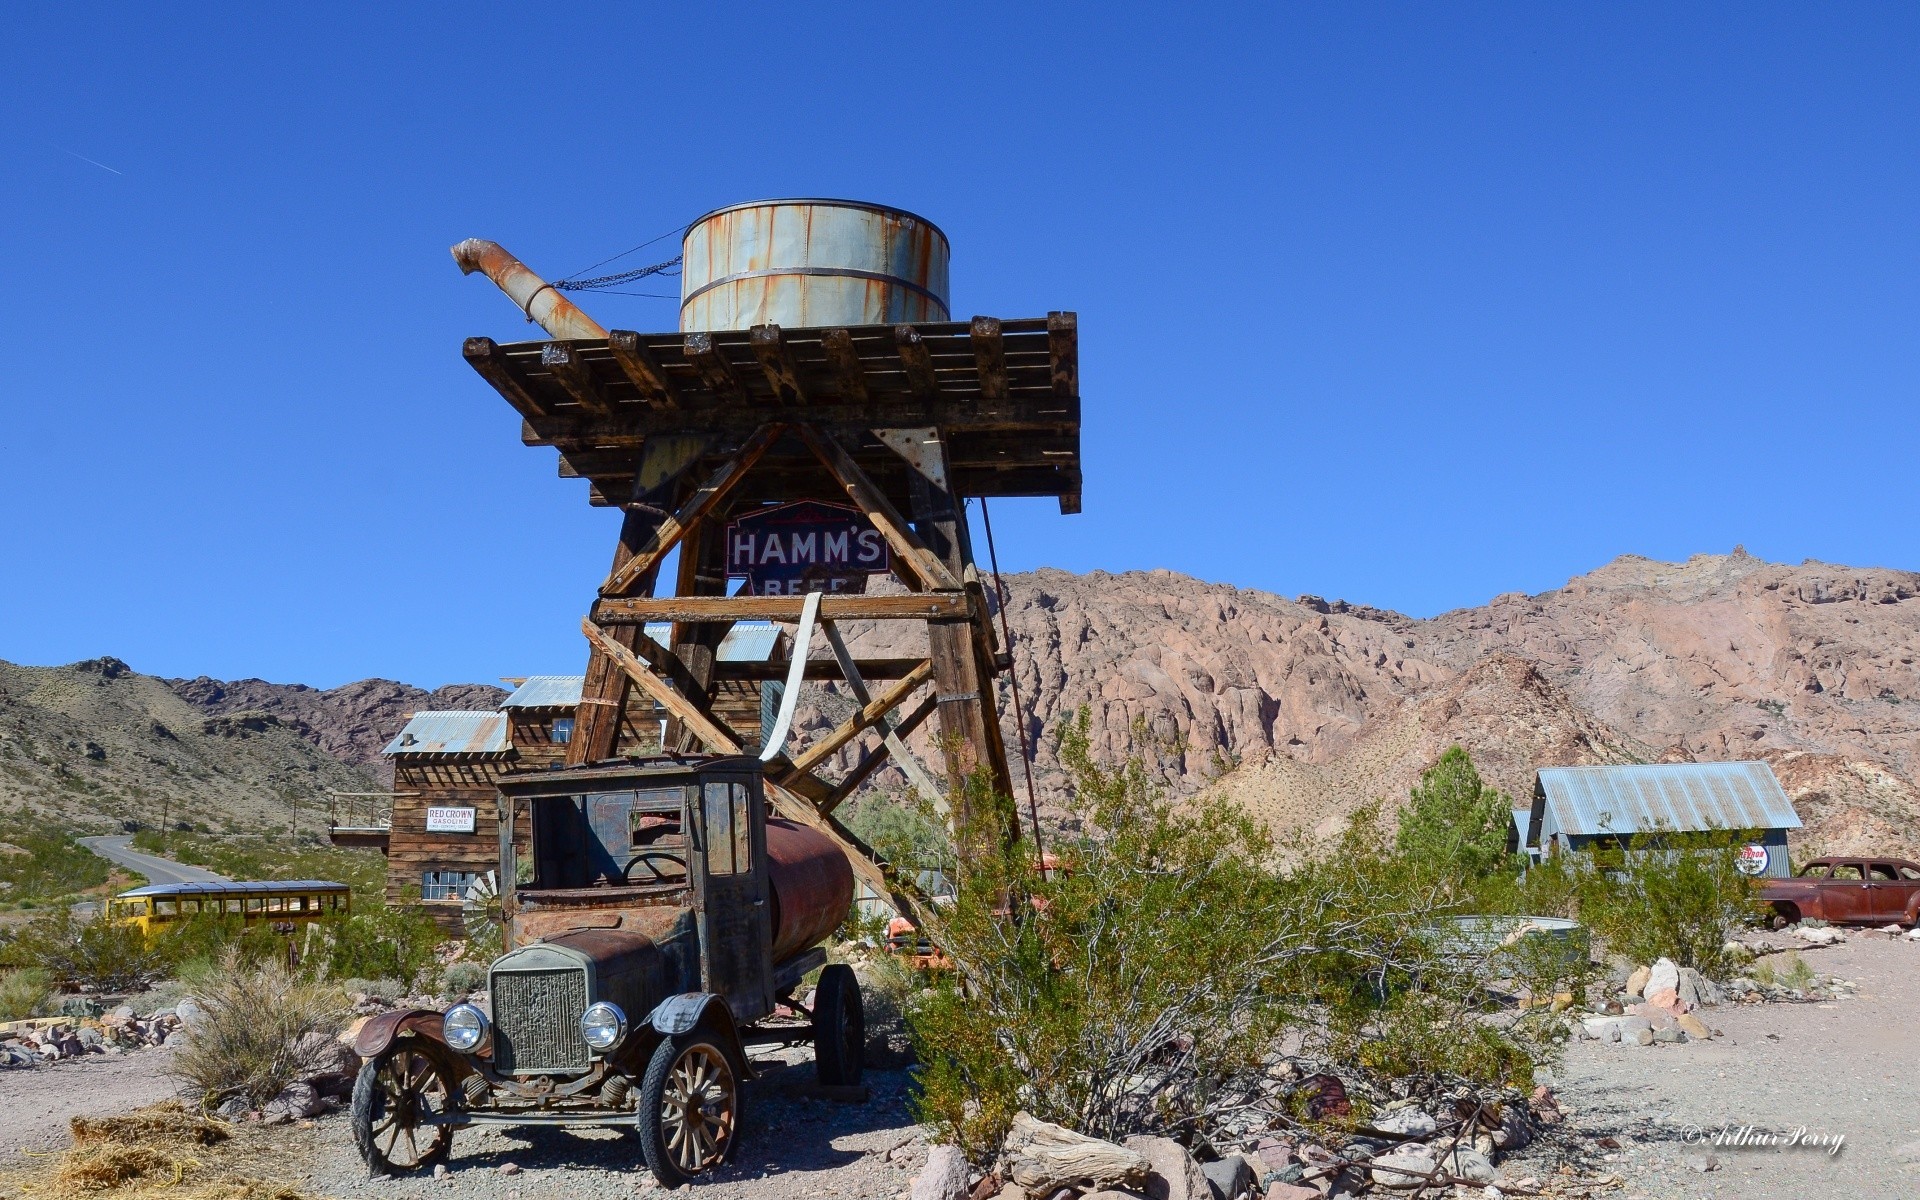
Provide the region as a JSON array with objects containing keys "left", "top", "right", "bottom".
[{"left": 639, "top": 1029, "right": 741, "bottom": 1188}]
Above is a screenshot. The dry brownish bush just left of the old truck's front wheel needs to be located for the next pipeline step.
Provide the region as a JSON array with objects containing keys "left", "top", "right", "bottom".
[{"left": 173, "top": 950, "right": 348, "bottom": 1108}]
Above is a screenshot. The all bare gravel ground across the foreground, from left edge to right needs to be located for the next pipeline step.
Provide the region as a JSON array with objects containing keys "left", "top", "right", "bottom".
[{"left": 11, "top": 933, "right": 1920, "bottom": 1200}]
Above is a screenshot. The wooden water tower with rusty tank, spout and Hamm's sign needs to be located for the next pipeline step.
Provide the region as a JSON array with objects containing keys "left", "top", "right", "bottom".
[{"left": 453, "top": 200, "right": 1081, "bottom": 895}]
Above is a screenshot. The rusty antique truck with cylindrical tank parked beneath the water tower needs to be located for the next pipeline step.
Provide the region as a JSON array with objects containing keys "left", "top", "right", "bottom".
[{"left": 351, "top": 756, "right": 866, "bottom": 1187}]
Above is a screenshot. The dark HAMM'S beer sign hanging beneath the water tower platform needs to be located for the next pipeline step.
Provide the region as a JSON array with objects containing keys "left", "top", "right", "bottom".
[{"left": 726, "top": 499, "right": 893, "bottom": 595}]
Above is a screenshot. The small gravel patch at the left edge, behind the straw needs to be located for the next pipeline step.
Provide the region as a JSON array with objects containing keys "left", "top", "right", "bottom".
[{"left": 0, "top": 1046, "right": 179, "bottom": 1169}]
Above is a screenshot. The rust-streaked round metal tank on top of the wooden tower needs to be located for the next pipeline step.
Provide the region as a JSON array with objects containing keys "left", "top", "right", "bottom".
[{"left": 680, "top": 200, "right": 948, "bottom": 332}]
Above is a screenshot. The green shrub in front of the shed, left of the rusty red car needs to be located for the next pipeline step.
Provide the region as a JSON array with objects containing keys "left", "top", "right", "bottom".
[{"left": 1567, "top": 833, "right": 1761, "bottom": 979}]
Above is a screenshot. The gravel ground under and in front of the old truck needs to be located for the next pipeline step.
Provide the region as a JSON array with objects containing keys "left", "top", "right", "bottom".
[{"left": 301, "top": 1050, "right": 925, "bottom": 1200}]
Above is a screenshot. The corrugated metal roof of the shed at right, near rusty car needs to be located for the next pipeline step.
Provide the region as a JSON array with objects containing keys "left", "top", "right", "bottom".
[{"left": 1530, "top": 762, "right": 1801, "bottom": 841}]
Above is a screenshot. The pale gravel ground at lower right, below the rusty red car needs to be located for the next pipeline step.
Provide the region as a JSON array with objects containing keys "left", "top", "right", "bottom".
[{"left": 1501, "top": 931, "right": 1920, "bottom": 1200}]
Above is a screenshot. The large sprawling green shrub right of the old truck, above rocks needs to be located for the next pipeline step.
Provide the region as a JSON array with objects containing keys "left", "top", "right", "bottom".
[{"left": 908, "top": 712, "right": 1530, "bottom": 1158}]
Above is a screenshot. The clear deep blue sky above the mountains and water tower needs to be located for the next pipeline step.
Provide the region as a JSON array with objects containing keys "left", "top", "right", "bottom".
[{"left": 0, "top": 4, "right": 1920, "bottom": 685}]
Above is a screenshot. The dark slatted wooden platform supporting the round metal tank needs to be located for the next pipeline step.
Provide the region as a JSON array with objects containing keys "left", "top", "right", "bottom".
[{"left": 465, "top": 313, "right": 1081, "bottom": 513}]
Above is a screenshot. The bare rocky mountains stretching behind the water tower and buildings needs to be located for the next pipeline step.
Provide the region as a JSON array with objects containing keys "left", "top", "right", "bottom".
[{"left": 0, "top": 551, "right": 1920, "bottom": 858}]
